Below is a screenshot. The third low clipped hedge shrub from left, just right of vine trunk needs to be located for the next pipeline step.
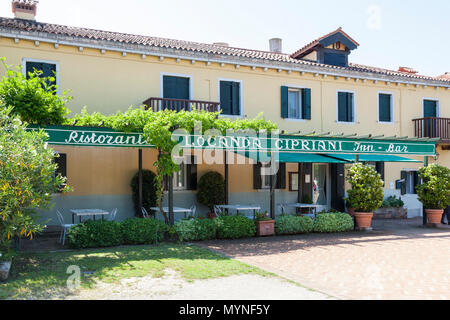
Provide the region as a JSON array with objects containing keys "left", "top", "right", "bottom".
[{"left": 174, "top": 219, "right": 217, "bottom": 241}]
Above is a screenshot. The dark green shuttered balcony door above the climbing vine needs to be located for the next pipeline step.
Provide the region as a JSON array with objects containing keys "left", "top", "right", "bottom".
[{"left": 162, "top": 76, "right": 190, "bottom": 111}]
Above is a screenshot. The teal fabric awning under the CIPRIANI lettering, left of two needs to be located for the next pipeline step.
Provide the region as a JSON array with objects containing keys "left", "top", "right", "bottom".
[{"left": 236, "top": 152, "right": 349, "bottom": 163}]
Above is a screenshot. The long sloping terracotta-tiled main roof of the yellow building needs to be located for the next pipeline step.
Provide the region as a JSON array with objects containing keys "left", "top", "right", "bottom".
[{"left": 0, "top": 17, "right": 450, "bottom": 85}]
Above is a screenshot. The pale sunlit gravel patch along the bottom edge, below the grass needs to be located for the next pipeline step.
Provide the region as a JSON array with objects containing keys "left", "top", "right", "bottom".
[{"left": 67, "top": 270, "right": 332, "bottom": 300}]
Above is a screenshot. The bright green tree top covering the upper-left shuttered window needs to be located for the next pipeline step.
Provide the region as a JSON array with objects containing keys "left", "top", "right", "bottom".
[{"left": 0, "top": 58, "right": 72, "bottom": 126}]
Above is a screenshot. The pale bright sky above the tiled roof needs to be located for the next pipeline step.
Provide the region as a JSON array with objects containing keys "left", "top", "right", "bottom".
[{"left": 0, "top": 0, "right": 450, "bottom": 76}]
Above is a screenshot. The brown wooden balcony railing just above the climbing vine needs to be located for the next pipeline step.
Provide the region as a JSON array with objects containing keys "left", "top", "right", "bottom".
[{"left": 143, "top": 98, "right": 220, "bottom": 112}]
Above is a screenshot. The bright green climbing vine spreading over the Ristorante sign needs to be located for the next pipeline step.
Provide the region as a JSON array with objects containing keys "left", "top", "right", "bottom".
[{"left": 65, "top": 107, "right": 276, "bottom": 222}]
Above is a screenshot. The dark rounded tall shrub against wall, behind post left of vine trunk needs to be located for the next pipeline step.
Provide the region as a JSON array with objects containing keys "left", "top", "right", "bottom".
[{"left": 130, "top": 170, "right": 156, "bottom": 217}]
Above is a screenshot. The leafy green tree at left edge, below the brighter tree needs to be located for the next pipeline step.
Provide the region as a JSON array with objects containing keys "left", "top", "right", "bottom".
[{"left": 0, "top": 107, "right": 69, "bottom": 252}]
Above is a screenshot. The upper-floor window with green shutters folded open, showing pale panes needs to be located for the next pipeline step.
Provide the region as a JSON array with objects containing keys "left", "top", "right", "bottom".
[{"left": 281, "top": 86, "right": 311, "bottom": 120}]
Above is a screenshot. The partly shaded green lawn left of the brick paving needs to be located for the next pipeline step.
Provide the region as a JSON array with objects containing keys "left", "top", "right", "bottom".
[{"left": 0, "top": 244, "right": 272, "bottom": 299}]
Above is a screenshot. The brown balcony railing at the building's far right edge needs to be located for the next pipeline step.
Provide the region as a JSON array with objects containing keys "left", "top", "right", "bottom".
[{"left": 413, "top": 117, "right": 450, "bottom": 143}]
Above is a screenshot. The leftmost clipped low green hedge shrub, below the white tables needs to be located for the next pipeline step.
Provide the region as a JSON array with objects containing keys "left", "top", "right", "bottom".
[{"left": 67, "top": 220, "right": 122, "bottom": 249}]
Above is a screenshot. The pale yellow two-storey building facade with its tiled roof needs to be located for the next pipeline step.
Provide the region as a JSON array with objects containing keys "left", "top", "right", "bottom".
[{"left": 0, "top": 2, "right": 450, "bottom": 224}]
